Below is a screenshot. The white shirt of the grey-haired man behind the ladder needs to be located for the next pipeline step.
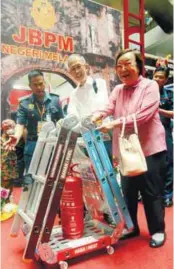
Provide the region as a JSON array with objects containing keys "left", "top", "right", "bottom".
[{"left": 67, "top": 77, "right": 109, "bottom": 119}]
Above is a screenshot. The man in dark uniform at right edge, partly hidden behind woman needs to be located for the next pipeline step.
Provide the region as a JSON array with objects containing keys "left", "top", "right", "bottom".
[{"left": 153, "top": 66, "right": 174, "bottom": 207}]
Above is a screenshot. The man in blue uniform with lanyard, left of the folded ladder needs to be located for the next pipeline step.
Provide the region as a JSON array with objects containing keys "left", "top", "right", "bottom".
[{"left": 4, "top": 70, "right": 63, "bottom": 184}]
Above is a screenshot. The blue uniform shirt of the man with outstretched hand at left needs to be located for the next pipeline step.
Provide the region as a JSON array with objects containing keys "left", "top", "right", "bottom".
[{"left": 17, "top": 93, "right": 63, "bottom": 138}]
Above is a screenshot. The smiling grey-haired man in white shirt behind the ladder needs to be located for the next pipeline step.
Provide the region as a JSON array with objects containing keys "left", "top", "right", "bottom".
[{"left": 67, "top": 54, "right": 108, "bottom": 118}]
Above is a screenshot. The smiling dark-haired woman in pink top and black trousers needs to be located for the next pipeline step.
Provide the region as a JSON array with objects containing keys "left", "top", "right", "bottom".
[{"left": 92, "top": 50, "right": 166, "bottom": 247}]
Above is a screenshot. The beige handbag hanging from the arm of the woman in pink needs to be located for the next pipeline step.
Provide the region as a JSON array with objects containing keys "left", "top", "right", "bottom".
[{"left": 119, "top": 114, "right": 147, "bottom": 177}]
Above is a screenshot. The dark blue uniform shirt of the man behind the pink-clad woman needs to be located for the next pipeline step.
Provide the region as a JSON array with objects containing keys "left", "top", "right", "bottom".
[{"left": 160, "top": 87, "right": 173, "bottom": 129}]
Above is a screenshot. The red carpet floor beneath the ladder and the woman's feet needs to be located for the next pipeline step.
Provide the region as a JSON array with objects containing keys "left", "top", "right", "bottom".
[{"left": 1, "top": 188, "right": 173, "bottom": 269}]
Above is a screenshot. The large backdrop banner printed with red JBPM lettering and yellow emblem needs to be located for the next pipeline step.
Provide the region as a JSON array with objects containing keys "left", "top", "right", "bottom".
[{"left": 1, "top": 0, "right": 121, "bottom": 115}]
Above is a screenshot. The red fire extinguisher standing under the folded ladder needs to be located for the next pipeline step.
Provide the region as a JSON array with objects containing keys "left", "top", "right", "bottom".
[{"left": 60, "top": 164, "right": 84, "bottom": 239}]
